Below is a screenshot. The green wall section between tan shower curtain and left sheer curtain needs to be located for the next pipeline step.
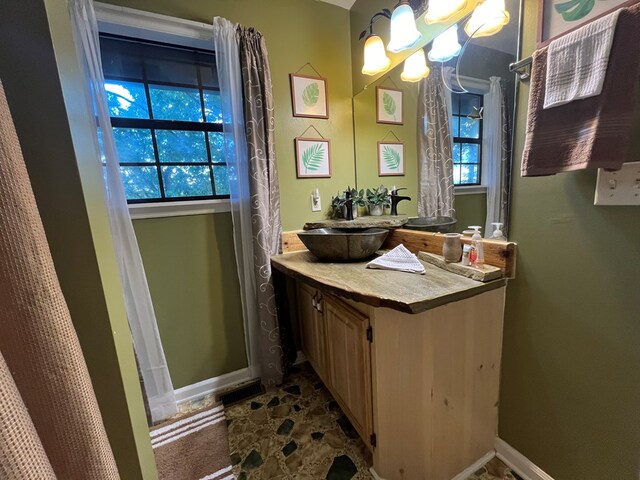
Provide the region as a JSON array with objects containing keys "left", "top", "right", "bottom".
[{"left": 0, "top": 0, "right": 157, "bottom": 479}]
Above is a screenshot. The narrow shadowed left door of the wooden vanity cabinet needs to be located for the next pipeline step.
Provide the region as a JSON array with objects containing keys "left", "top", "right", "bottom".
[{"left": 298, "top": 282, "right": 327, "bottom": 383}]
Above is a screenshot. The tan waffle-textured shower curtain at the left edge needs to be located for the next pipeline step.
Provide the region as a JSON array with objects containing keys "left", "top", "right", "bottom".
[{"left": 0, "top": 82, "right": 119, "bottom": 480}]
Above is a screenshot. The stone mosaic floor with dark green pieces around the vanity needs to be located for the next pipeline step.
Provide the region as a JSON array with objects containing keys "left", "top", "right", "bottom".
[{"left": 222, "top": 364, "right": 521, "bottom": 480}]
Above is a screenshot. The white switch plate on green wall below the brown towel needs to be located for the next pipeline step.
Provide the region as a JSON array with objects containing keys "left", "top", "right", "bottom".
[{"left": 593, "top": 162, "right": 640, "bottom": 205}]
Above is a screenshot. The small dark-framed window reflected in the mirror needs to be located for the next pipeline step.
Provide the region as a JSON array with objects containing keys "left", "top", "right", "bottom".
[{"left": 451, "top": 93, "right": 483, "bottom": 185}]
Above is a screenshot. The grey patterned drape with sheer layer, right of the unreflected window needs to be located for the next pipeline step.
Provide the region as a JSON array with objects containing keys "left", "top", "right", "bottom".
[{"left": 213, "top": 17, "right": 283, "bottom": 385}]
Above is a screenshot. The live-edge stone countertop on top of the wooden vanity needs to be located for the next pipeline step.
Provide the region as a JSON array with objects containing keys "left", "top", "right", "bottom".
[{"left": 271, "top": 251, "right": 506, "bottom": 313}]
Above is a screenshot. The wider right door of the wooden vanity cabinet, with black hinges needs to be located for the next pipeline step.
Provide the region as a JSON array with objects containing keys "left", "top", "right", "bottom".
[{"left": 324, "top": 296, "right": 373, "bottom": 444}]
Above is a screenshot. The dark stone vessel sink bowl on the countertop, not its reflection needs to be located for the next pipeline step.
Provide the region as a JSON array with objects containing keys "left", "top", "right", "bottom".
[{"left": 298, "top": 228, "right": 389, "bottom": 262}]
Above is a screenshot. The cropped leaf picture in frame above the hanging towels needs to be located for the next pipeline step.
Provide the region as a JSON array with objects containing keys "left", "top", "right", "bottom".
[{"left": 538, "top": 0, "right": 638, "bottom": 48}]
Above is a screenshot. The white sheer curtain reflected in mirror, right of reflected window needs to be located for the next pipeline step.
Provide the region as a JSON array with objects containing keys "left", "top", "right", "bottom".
[{"left": 482, "top": 77, "right": 511, "bottom": 237}]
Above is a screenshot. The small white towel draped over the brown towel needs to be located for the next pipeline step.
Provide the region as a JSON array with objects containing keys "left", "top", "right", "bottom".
[{"left": 544, "top": 9, "right": 633, "bottom": 109}]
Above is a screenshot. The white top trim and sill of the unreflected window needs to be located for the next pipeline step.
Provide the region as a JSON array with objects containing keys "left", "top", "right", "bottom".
[{"left": 94, "top": 2, "right": 231, "bottom": 219}]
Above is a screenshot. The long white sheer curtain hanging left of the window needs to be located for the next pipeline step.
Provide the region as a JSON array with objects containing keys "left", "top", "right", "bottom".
[{"left": 69, "top": 0, "right": 178, "bottom": 423}]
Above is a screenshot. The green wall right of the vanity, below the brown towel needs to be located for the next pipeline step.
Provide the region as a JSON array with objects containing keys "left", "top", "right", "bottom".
[{"left": 499, "top": 1, "right": 640, "bottom": 480}]
